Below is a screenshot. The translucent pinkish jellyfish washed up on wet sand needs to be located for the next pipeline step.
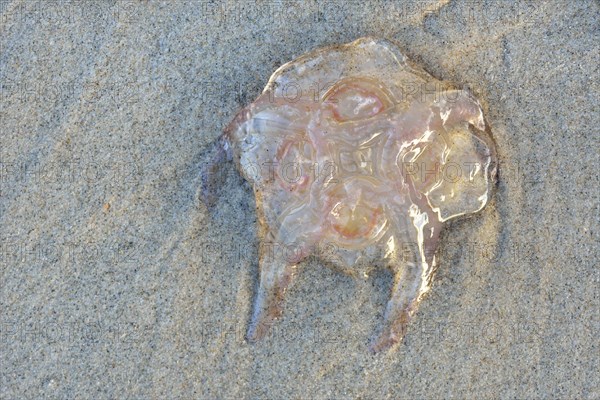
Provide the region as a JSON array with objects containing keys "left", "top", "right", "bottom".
[{"left": 202, "top": 38, "right": 497, "bottom": 351}]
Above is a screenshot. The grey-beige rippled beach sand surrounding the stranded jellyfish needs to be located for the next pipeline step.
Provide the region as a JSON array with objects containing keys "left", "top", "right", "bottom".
[{"left": 0, "top": 0, "right": 600, "bottom": 399}]
